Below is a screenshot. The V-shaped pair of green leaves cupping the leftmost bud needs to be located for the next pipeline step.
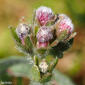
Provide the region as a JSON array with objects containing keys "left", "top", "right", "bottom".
[{"left": 10, "top": 27, "right": 33, "bottom": 54}]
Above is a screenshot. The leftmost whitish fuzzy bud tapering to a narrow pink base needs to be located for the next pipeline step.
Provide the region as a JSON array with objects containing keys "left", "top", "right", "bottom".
[{"left": 16, "top": 23, "right": 29, "bottom": 45}]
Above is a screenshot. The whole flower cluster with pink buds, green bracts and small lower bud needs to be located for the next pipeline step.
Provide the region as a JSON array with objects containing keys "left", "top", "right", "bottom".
[{"left": 11, "top": 6, "right": 76, "bottom": 82}]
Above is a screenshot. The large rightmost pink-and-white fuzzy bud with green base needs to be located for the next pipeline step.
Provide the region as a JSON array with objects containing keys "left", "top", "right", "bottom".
[{"left": 56, "top": 14, "right": 74, "bottom": 40}]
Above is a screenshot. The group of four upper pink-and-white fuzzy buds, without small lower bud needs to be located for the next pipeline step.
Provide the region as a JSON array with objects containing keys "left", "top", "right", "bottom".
[{"left": 16, "top": 6, "right": 74, "bottom": 49}]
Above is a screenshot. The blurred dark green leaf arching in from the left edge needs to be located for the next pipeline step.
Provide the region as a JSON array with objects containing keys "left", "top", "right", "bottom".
[{"left": 0, "top": 57, "right": 27, "bottom": 75}]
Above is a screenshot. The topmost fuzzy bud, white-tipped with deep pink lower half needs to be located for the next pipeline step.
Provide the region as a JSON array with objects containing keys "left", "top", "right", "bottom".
[{"left": 36, "top": 6, "right": 54, "bottom": 26}]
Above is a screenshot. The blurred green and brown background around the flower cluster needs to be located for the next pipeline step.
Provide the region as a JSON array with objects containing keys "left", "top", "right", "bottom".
[{"left": 0, "top": 0, "right": 85, "bottom": 85}]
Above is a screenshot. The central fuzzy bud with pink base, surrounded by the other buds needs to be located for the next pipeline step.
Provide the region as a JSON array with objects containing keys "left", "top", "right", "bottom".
[{"left": 37, "top": 26, "right": 53, "bottom": 48}]
